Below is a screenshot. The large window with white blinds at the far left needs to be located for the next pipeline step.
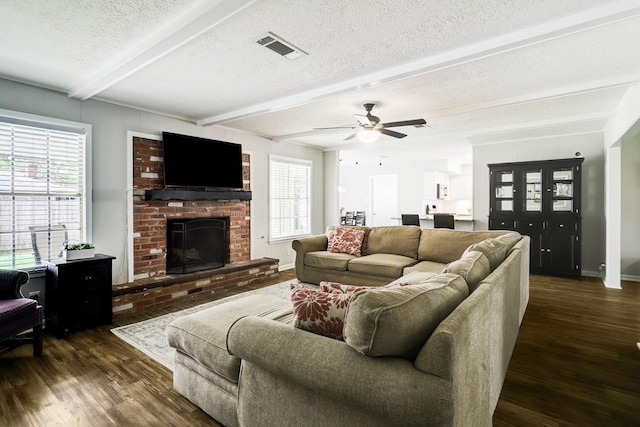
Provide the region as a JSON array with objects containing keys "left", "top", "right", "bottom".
[{"left": 0, "top": 110, "right": 91, "bottom": 269}]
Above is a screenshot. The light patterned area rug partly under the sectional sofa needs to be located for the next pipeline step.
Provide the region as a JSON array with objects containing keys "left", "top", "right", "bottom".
[{"left": 111, "top": 279, "right": 298, "bottom": 370}]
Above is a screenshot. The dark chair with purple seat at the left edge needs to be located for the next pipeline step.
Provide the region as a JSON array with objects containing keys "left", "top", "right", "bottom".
[{"left": 0, "top": 269, "right": 43, "bottom": 356}]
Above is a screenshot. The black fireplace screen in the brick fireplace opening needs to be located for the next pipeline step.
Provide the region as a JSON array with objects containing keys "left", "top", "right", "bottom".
[{"left": 167, "top": 218, "right": 229, "bottom": 274}]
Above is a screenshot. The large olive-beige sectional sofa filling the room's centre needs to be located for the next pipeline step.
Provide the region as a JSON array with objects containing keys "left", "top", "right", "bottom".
[{"left": 167, "top": 226, "right": 529, "bottom": 426}]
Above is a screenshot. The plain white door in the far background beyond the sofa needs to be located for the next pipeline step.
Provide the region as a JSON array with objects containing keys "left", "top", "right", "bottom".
[{"left": 367, "top": 175, "right": 399, "bottom": 226}]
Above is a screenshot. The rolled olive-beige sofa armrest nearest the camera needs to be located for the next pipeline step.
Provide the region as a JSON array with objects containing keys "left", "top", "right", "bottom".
[{"left": 227, "top": 317, "right": 452, "bottom": 424}]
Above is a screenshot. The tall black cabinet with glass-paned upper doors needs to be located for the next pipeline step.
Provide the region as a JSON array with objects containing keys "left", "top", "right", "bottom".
[{"left": 488, "top": 158, "right": 584, "bottom": 279}]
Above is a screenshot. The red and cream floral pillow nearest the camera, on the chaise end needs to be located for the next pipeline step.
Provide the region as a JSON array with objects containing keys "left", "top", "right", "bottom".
[{"left": 291, "top": 284, "right": 354, "bottom": 340}]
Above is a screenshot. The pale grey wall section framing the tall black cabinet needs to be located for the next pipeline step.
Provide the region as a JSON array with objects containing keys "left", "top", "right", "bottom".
[{"left": 473, "top": 134, "right": 606, "bottom": 276}]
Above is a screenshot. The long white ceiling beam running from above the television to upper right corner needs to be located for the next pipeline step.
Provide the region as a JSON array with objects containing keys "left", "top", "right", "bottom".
[{"left": 197, "top": 0, "right": 640, "bottom": 126}]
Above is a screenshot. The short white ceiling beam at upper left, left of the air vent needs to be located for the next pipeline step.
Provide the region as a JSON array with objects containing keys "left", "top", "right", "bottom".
[{"left": 68, "top": 0, "right": 257, "bottom": 101}]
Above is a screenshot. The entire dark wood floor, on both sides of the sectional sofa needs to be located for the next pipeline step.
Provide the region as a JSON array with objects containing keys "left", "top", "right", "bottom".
[{"left": 0, "top": 271, "right": 640, "bottom": 426}]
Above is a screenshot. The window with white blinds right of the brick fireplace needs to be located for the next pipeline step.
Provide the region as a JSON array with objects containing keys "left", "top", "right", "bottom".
[{"left": 269, "top": 156, "right": 311, "bottom": 241}]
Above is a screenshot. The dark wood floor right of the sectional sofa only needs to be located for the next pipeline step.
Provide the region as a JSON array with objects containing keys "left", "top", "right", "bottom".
[{"left": 493, "top": 276, "right": 640, "bottom": 426}]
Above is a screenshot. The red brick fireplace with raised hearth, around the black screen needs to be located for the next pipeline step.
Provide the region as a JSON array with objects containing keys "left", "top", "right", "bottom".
[{"left": 113, "top": 137, "right": 278, "bottom": 317}]
